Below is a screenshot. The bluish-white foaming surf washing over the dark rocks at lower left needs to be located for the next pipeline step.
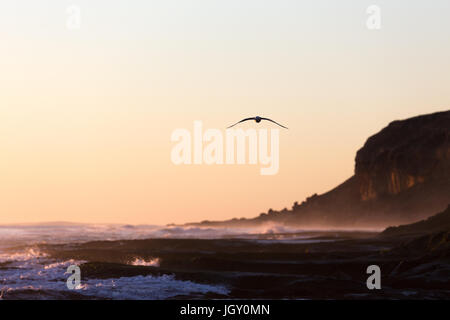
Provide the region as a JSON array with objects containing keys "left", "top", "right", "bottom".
[{"left": 0, "top": 248, "right": 228, "bottom": 299}]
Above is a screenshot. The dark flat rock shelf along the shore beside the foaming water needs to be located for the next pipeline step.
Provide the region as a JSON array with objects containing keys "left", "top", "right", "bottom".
[{"left": 27, "top": 232, "right": 442, "bottom": 299}]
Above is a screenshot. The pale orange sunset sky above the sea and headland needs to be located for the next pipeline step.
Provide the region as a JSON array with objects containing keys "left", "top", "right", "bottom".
[{"left": 0, "top": 0, "right": 450, "bottom": 224}]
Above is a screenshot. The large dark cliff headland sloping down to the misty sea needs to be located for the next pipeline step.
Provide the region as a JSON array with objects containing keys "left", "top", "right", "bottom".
[{"left": 188, "top": 111, "right": 450, "bottom": 227}]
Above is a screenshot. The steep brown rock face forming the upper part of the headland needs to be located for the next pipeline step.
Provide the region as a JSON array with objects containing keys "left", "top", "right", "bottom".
[{"left": 355, "top": 112, "right": 450, "bottom": 201}]
